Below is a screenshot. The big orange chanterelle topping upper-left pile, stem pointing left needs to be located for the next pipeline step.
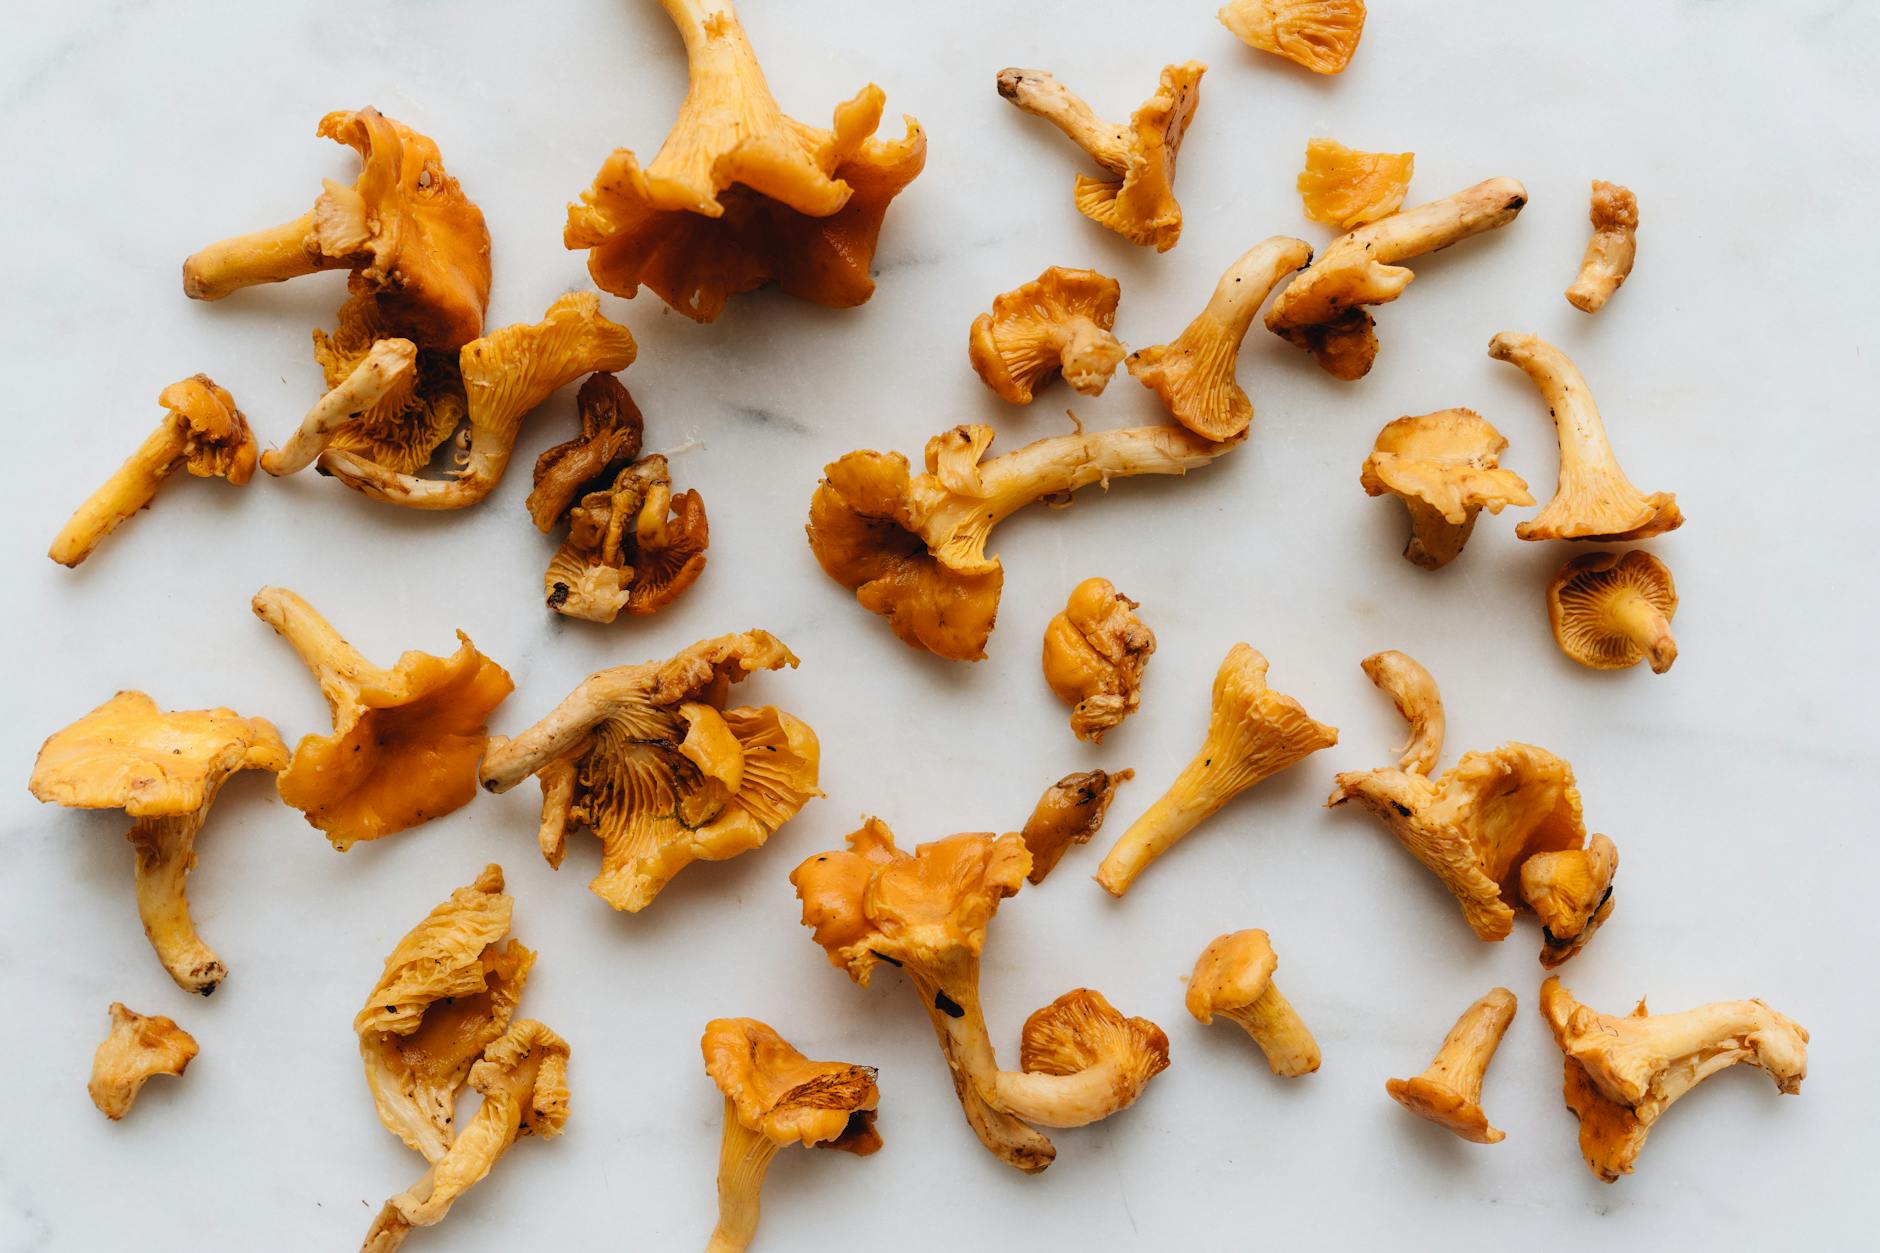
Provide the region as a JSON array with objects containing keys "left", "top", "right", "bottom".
[{"left": 182, "top": 109, "right": 489, "bottom": 348}]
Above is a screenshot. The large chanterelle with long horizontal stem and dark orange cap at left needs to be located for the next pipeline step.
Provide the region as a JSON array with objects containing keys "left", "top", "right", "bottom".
[{"left": 807, "top": 425, "right": 1233, "bottom": 660}]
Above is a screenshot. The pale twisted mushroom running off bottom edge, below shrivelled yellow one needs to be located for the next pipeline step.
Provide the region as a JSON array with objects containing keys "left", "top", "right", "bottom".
[{"left": 361, "top": 1018, "right": 568, "bottom": 1253}]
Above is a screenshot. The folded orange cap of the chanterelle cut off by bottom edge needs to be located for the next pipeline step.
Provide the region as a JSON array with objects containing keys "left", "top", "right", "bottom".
[{"left": 699, "top": 1018, "right": 882, "bottom": 1157}]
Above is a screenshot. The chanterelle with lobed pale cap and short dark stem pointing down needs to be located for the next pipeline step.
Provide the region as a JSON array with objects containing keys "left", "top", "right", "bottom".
[{"left": 1357, "top": 408, "right": 1534, "bottom": 570}]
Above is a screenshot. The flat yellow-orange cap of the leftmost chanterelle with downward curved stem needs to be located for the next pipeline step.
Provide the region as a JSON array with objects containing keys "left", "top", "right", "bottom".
[{"left": 28, "top": 692, "right": 288, "bottom": 818}]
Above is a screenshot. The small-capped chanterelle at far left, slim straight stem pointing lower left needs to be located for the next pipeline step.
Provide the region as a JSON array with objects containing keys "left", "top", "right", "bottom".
[{"left": 45, "top": 374, "right": 256, "bottom": 566}]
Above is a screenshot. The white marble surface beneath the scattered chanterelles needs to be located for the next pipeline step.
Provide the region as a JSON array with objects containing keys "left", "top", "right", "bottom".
[{"left": 0, "top": 0, "right": 1880, "bottom": 1253}]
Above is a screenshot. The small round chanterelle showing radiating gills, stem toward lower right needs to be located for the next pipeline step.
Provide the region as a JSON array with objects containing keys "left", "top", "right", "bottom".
[{"left": 1547, "top": 549, "right": 1677, "bottom": 674}]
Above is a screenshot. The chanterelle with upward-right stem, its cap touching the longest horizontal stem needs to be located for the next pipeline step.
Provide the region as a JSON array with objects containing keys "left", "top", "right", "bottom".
[{"left": 1130, "top": 235, "right": 1312, "bottom": 440}]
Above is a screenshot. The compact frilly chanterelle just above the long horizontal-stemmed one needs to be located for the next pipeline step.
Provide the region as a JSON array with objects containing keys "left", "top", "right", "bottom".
[{"left": 966, "top": 265, "right": 1122, "bottom": 404}]
